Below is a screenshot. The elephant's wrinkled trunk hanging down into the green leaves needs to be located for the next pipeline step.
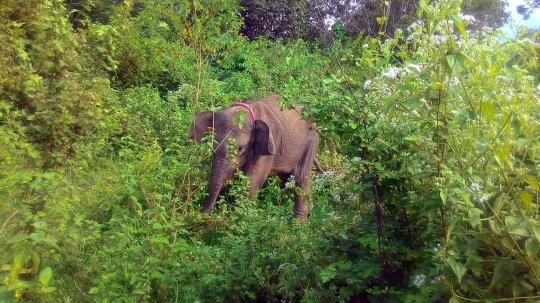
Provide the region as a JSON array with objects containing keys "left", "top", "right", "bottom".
[{"left": 201, "top": 159, "right": 236, "bottom": 213}]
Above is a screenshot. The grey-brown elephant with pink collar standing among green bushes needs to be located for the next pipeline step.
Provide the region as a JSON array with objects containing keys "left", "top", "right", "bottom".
[{"left": 189, "top": 96, "right": 320, "bottom": 221}]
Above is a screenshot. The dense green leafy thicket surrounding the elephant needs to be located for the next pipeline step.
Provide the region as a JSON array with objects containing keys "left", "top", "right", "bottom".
[{"left": 0, "top": 0, "right": 540, "bottom": 302}]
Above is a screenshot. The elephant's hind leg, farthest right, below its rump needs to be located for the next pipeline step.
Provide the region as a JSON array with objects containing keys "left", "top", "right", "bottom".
[{"left": 294, "top": 132, "right": 319, "bottom": 222}]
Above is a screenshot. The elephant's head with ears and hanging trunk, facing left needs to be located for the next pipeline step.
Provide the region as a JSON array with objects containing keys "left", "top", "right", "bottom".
[{"left": 189, "top": 104, "right": 276, "bottom": 212}]
